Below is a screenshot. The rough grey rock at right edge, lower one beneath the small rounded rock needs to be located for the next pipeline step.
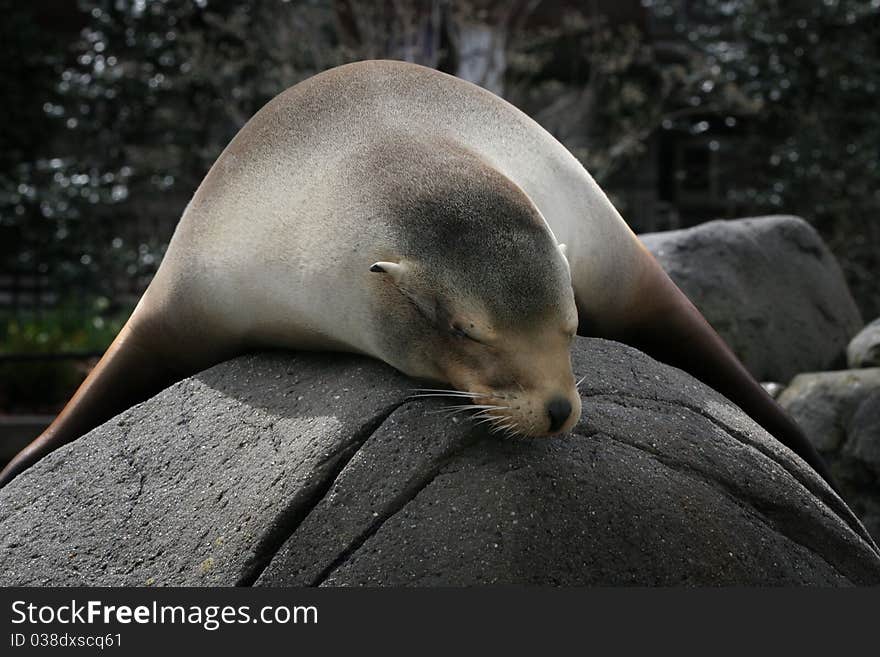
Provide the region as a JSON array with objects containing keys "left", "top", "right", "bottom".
[{"left": 779, "top": 368, "right": 880, "bottom": 540}]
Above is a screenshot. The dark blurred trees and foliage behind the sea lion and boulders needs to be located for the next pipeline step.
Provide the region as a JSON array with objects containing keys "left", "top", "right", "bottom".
[{"left": 0, "top": 0, "right": 880, "bottom": 418}]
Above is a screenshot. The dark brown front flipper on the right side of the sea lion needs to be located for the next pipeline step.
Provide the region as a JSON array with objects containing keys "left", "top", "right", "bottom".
[{"left": 591, "top": 252, "right": 840, "bottom": 493}]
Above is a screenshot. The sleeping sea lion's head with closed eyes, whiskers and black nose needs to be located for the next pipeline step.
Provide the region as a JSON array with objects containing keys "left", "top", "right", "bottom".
[{"left": 364, "top": 167, "right": 581, "bottom": 436}]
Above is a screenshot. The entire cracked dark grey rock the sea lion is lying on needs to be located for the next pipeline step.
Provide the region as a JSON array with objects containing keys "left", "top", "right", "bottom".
[{"left": 0, "top": 339, "right": 880, "bottom": 586}]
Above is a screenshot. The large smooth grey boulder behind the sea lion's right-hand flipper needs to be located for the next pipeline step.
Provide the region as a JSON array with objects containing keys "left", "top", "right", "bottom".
[{"left": 640, "top": 216, "right": 862, "bottom": 382}]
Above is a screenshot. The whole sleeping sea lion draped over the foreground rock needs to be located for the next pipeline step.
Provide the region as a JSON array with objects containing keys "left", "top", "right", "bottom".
[{"left": 0, "top": 61, "right": 831, "bottom": 485}]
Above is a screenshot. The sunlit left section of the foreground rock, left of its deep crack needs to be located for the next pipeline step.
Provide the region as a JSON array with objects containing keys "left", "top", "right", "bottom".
[{"left": 0, "top": 354, "right": 410, "bottom": 586}]
